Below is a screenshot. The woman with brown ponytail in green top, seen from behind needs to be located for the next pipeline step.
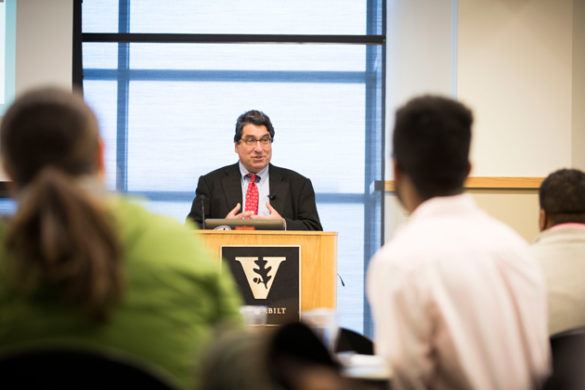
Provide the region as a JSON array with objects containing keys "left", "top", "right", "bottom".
[{"left": 0, "top": 88, "right": 240, "bottom": 388}]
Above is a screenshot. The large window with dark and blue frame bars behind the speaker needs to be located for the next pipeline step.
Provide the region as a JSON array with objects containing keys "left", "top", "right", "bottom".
[{"left": 74, "top": 0, "right": 385, "bottom": 332}]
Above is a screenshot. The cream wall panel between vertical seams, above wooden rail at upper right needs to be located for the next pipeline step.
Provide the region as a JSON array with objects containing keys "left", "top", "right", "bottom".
[{"left": 457, "top": 0, "right": 573, "bottom": 177}]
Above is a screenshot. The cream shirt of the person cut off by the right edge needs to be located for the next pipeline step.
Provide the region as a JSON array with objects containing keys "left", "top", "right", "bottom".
[{"left": 532, "top": 223, "right": 585, "bottom": 334}]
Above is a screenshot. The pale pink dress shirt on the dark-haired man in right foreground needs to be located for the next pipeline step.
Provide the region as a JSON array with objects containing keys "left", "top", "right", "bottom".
[{"left": 367, "top": 195, "right": 550, "bottom": 390}]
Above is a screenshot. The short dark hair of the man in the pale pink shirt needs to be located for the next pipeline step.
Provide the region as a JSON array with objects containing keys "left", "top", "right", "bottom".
[{"left": 393, "top": 95, "right": 473, "bottom": 200}]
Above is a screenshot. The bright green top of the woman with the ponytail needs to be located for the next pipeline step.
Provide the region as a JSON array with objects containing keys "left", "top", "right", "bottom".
[{"left": 0, "top": 197, "right": 241, "bottom": 389}]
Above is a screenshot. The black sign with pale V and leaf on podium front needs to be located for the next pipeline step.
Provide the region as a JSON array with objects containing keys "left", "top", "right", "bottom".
[{"left": 221, "top": 246, "right": 301, "bottom": 324}]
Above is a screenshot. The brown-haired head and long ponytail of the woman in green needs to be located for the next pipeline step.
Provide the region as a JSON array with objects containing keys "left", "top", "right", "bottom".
[{"left": 0, "top": 88, "right": 118, "bottom": 323}]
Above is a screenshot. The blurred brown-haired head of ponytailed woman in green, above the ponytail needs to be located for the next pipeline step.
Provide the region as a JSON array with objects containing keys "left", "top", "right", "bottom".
[{"left": 0, "top": 88, "right": 102, "bottom": 188}]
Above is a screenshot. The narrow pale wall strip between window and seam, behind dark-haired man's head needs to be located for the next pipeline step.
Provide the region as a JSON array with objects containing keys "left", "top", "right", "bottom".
[{"left": 385, "top": 0, "right": 457, "bottom": 180}]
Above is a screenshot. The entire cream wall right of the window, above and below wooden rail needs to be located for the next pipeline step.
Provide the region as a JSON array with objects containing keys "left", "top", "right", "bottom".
[{"left": 385, "top": 0, "right": 585, "bottom": 241}]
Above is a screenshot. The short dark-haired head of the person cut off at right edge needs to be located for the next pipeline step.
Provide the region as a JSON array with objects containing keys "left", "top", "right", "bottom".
[{"left": 538, "top": 169, "right": 585, "bottom": 226}]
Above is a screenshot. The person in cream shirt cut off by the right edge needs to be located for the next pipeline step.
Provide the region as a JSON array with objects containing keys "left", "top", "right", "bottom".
[{"left": 532, "top": 169, "right": 585, "bottom": 335}]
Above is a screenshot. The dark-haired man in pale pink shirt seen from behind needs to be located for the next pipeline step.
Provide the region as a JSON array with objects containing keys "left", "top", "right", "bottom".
[{"left": 367, "top": 96, "right": 550, "bottom": 390}]
